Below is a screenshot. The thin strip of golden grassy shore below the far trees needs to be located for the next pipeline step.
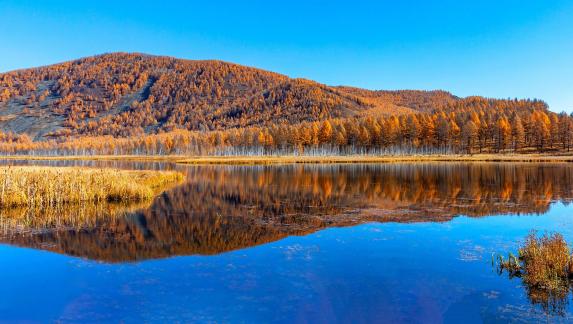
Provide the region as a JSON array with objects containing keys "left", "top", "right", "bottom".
[{"left": 0, "top": 154, "right": 573, "bottom": 165}]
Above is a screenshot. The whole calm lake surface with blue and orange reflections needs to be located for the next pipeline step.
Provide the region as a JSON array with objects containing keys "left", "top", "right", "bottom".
[{"left": 0, "top": 161, "right": 573, "bottom": 323}]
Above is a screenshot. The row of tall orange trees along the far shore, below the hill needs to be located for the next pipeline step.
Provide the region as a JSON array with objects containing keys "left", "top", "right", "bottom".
[{"left": 0, "top": 109, "right": 573, "bottom": 155}]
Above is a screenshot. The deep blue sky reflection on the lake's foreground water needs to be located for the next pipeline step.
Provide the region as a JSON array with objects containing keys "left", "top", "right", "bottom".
[{"left": 0, "top": 203, "right": 573, "bottom": 323}]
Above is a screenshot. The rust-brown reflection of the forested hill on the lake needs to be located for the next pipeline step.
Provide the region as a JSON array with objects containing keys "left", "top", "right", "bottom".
[{"left": 0, "top": 163, "right": 573, "bottom": 263}]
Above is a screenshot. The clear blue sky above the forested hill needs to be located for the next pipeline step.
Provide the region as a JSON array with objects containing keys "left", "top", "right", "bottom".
[{"left": 0, "top": 0, "right": 573, "bottom": 111}]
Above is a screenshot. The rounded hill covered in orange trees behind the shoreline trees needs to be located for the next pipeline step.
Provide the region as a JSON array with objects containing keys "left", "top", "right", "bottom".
[{"left": 0, "top": 53, "right": 547, "bottom": 141}]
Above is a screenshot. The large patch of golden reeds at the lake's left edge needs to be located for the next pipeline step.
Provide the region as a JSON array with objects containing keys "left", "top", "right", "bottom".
[{"left": 0, "top": 167, "right": 183, "bottom": 209}]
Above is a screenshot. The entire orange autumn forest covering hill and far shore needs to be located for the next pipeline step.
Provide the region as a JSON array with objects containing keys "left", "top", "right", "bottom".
[{"left": 0, "top": 53, "right": 573, "bottom": 155}]
